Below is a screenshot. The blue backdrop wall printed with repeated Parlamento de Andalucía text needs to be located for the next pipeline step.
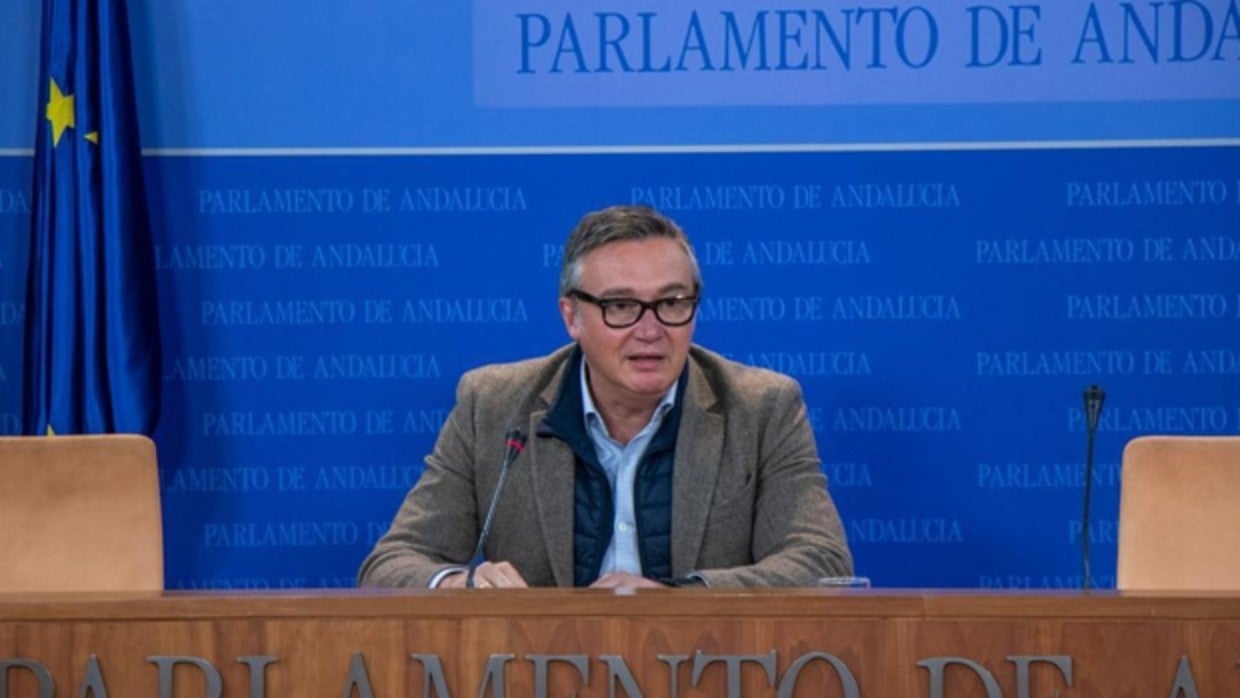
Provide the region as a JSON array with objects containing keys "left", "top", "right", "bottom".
[{"left": 0, "top": 0, "right": 1240, "bottom": 588}]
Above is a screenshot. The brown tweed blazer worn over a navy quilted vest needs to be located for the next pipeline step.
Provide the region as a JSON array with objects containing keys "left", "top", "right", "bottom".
[{"left": 358, "top": 345, "right": 852, "bottom": 586}]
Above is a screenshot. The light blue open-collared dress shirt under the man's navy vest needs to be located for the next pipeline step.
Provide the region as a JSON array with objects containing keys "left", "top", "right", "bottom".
[{"left": 582, "top": 361, "right": 677, "bottom": 577}]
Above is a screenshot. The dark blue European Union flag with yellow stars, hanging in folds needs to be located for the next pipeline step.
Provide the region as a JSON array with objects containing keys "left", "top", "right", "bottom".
[{"left": 22, "top": 0, "right": 160, "bottom": 434}]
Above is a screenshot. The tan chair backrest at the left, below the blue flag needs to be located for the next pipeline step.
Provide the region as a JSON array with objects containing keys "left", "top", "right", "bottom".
[{"left": 0, "top": 434, "right": 164, "bottom": 591}]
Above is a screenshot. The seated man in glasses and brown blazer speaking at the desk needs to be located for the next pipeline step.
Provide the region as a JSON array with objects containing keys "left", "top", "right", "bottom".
[{"left": 358, "top": 206, "right": 852, "bottom": 588}]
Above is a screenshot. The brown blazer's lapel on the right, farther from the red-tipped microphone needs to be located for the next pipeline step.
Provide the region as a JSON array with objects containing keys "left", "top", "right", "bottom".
[{"left": 672, "top": 360, "right": 723, "bottom": 577}]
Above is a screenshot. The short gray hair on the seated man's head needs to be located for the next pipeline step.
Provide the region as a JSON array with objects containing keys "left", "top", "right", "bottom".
[{"left": 559, "top": 206, "right": 702, "bottom": 296}]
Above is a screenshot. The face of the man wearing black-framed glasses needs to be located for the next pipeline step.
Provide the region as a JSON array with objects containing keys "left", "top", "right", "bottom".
[{"left": 559, "top": 238, "right": 697, "bottom": 409}]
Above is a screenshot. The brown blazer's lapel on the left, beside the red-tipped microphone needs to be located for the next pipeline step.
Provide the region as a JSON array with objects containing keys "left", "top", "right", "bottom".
[{"left": 527, "top": 376, "right": 577, "bottom": 586}]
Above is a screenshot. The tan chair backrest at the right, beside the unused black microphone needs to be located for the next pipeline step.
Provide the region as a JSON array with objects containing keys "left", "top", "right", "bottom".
[{"left": 1116, "top": 436, "right": 1240, "bottom": 591}]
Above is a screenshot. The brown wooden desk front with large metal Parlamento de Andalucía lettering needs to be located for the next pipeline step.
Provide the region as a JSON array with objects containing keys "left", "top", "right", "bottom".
[{"left": 0, "top": 589, "right": 1240, "bottom": 698}]
